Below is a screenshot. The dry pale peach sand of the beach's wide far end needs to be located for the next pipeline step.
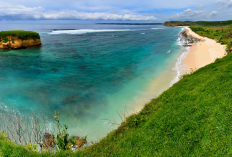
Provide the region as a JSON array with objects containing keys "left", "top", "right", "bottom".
[{"left": 182, "top": 27, "right": 226, "bottom": 74}]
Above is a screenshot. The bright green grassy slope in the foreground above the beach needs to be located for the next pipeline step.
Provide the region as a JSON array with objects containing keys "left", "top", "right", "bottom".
[{"left": 0, "top": 50, "right": 232, "bottom": 156}]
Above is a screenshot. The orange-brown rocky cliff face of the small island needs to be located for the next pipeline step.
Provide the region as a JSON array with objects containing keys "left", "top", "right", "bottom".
[{"left": 0, "top": 37, "right": 41, "bottom": 49}]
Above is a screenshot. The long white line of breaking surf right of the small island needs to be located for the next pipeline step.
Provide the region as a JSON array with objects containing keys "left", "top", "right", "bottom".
[{"left": 48, "top": 29, "right": 130, "bottom": 34}]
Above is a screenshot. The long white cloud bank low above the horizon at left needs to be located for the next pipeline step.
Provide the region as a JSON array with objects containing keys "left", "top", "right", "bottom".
[{"left": 0, "top": 5, "right": 156, "bottom": 21}]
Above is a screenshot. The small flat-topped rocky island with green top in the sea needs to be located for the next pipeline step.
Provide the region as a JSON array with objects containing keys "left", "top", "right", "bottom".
[{"left": 0, "top": 30, "right": 41, "bottom": 49}]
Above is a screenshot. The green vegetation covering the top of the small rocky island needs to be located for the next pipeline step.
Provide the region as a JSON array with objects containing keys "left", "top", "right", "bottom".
[{"left": 0, "top": 30, "right": 40, "bottom": 43}]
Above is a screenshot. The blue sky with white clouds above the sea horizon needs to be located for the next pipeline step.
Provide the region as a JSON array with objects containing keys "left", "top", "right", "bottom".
[{"left": 0, "top": 0, "right": 232, "bottom": 23}]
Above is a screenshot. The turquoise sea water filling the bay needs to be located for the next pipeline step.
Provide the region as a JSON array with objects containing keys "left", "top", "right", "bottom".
[{"left": 0, "top": 25, "right": 183, "bottom": 140}]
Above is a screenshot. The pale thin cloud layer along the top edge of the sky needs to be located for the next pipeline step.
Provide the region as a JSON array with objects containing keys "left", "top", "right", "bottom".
[{"left": 1, "top": 0, "right": 212, "bottom": 12}]
